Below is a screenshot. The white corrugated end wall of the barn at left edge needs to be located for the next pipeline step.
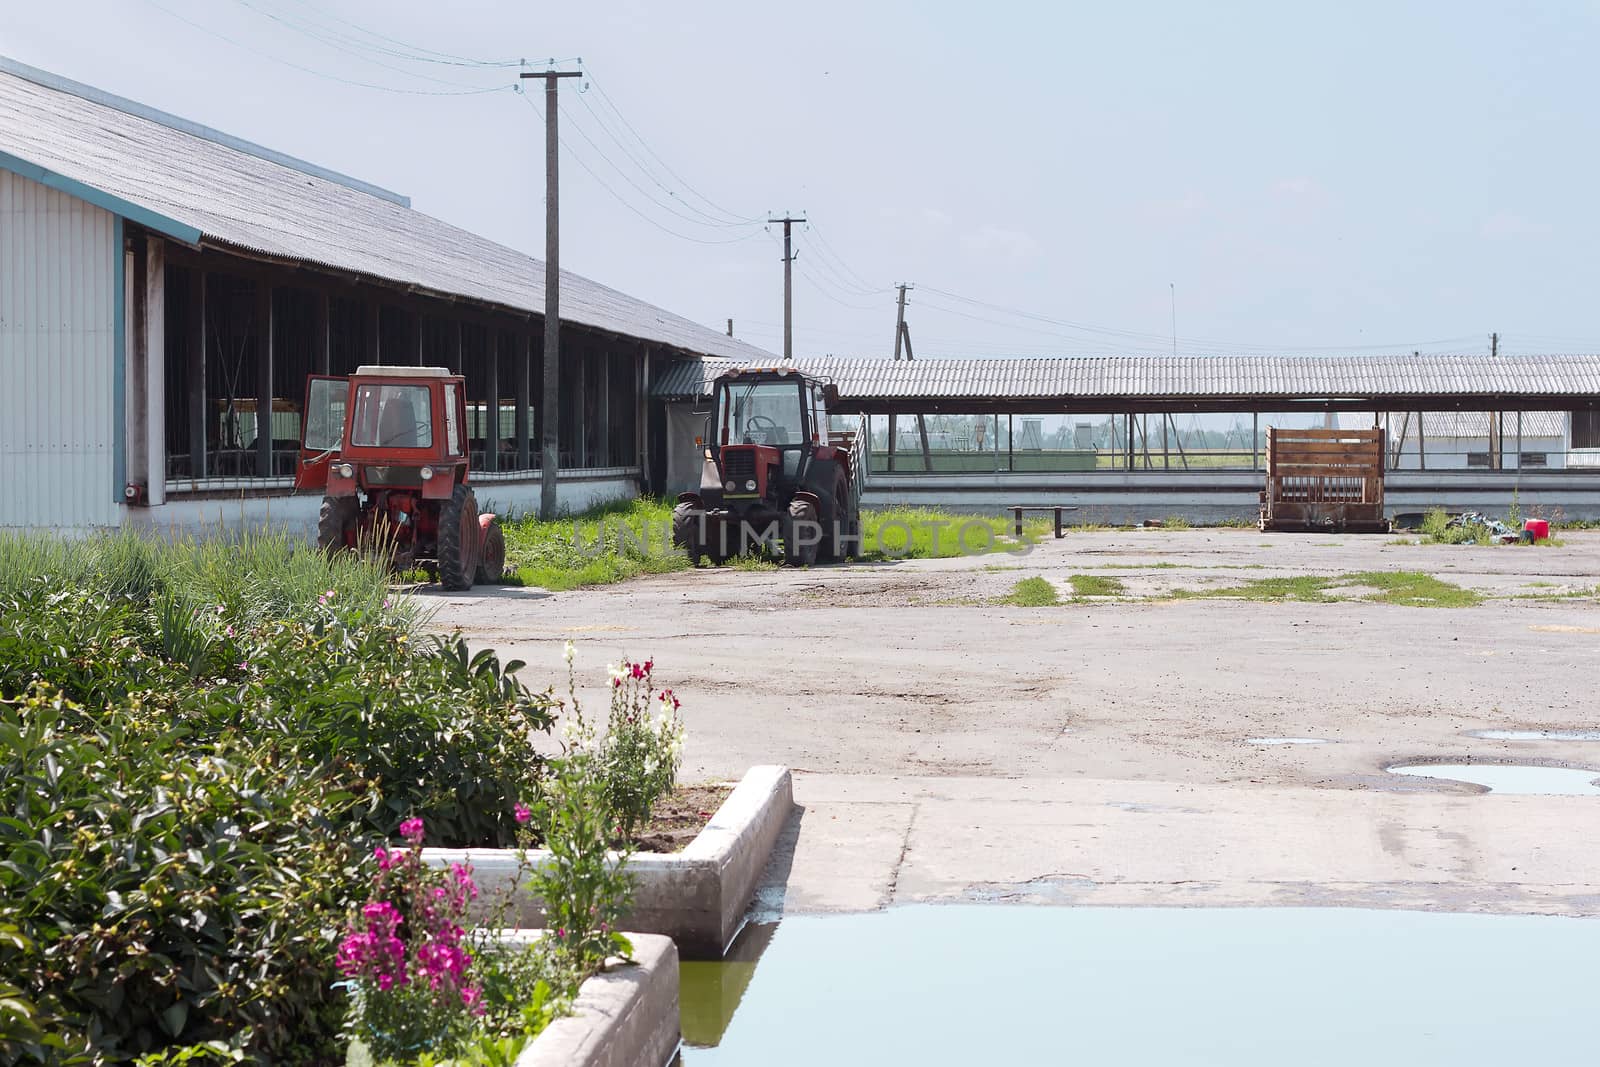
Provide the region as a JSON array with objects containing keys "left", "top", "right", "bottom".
[{"left": 0, "top": 170, "right": 120, "bottom": 530}]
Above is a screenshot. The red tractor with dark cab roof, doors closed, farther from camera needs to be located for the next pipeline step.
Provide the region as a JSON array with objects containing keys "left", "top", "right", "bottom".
[{"left": 672, "top": 366, "right": 861, "bottom": 566}]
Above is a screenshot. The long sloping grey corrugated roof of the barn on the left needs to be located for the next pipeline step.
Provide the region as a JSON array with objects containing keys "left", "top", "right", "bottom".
[{"left": 0, "top": 59, "right": 774, "bottom": 367}]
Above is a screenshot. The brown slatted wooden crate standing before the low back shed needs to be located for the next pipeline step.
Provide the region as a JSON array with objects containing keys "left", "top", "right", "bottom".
[{"left": 1261, "top": 427, "right": 1389, "bottom": 533}]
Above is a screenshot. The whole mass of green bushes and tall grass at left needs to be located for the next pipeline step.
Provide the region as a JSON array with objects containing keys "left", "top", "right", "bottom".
[{"left": 0, "top": 534, "right": 552, "bottom": 1064}]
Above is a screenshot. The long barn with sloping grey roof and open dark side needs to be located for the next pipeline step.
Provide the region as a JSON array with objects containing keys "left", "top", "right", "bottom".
[{"left": 0, "top": 59, "right": 773, "bottom": 530}]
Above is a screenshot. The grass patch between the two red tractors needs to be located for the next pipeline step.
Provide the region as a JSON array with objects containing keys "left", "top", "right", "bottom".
[{"left": 504, "top": 498, "right": 690, "bottom": 592}]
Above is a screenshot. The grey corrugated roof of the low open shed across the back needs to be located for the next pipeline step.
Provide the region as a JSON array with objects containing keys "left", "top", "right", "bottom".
[{"left": 654, "top": 355, "right": 1600, "bottom": 402}]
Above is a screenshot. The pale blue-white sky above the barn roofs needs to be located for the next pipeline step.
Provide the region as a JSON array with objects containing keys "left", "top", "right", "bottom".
[{"left": 0, "top": 0, "right": 1600, "bottom": 357}]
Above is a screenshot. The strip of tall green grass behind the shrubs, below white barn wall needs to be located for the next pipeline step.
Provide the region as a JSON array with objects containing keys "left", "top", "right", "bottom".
[{"left": 0, "top": 530, "right": 422, "bottom": 627}]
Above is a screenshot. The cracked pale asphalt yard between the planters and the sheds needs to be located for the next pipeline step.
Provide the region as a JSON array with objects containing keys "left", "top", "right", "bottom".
[{"left": 435, "top": 530, "right": 1600, "bottom": 915}]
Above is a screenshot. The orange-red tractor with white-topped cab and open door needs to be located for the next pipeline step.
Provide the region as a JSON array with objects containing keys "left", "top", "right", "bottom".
[{"left": 294, "top": 366, "right": 506, "bottom": 589}]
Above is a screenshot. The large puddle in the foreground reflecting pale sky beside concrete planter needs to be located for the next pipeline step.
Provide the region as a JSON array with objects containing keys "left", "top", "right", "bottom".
[{"left": 680, "top": 905, "right": 1600, "bottom": 1067}]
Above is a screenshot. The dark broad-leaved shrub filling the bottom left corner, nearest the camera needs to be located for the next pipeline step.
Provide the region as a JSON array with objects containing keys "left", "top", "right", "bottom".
[{"left": 0, "top": 691, "right": 366, "bottom": 1062}]
